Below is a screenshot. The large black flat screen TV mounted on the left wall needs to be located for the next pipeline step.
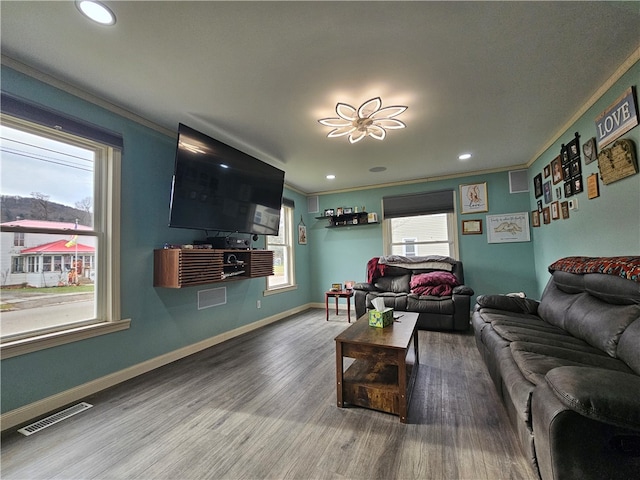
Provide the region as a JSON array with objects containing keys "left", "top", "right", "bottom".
[{"left": 169, "top": 124, "right": 284, "bottom": 235}]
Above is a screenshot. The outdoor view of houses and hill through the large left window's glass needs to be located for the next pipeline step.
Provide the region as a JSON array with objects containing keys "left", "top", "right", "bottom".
[{"left": 0, "top": 125, "right": 97, "bottom": 340}]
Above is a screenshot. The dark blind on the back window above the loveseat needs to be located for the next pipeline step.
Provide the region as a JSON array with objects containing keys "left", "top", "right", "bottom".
[{"left": 382, "top": 190, "right": 454, "bottom": 218}]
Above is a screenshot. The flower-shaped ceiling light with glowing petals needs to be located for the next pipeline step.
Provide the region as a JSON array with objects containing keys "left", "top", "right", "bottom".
[{"left": 318, "top": 97, "right": 408, "bottom": 143}]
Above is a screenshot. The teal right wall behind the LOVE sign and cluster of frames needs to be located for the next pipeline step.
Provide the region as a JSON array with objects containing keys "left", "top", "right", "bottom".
[{"left": 529, "top": 62, "right": 640, "bottom": 293}]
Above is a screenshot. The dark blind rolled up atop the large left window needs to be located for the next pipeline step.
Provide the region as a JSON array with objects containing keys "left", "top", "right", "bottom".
[{"left": 0, "top": 92, "right": 123, "bottom": 150}]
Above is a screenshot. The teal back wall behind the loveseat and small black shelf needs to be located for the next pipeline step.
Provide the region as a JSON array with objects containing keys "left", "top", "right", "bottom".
[{"left": 309, "top": 172, "right": 537, "bottom": 301}]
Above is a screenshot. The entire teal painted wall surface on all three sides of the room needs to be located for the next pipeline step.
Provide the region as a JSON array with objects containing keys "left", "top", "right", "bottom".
[{"left": 1, "top": 60, "right": 640, "bottom": 413}]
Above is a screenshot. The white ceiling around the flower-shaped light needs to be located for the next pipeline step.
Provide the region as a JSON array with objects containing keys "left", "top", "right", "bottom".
[{"left": 1, "top": 1, "right": 640, "bottom": 193}]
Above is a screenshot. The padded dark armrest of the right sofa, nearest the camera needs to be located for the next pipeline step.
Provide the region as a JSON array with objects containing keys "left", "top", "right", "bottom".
[{"left": 545, "top": 366, "right": 640, "bottom": 430}]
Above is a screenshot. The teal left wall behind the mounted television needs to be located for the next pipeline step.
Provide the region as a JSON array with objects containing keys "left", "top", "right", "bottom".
[{"left": 1, "top": 66, "right": 310, "bottom": 413}]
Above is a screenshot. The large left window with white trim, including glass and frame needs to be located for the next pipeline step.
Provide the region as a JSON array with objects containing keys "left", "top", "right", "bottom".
[{"left": 0, "top": 109, "right": 128, "bottom": 358}]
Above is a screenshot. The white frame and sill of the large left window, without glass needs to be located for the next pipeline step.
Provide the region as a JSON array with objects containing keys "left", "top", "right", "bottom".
[{"left": 0, "top": 114, "right": 131, "bottom": 359}]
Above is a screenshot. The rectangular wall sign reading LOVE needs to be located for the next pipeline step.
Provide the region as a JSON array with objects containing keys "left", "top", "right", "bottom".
[{"left": 596, "top": 87, "right": 638, "bottom": 148}]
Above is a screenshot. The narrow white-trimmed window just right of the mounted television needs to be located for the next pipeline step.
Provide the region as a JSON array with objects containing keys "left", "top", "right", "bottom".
[{"left": 267, "top": 204, "right": 295, "bottom": 291}]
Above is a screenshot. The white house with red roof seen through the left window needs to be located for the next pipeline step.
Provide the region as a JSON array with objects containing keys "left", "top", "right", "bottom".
[{"left": 0, "top": 220, "right": 95, "bottom": 287}]
